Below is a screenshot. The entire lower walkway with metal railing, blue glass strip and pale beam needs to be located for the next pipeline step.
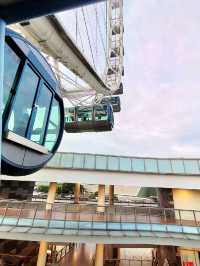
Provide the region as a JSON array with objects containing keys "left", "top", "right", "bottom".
[{"left": 0, "top": 201, "right": 200, "bottom": 247}]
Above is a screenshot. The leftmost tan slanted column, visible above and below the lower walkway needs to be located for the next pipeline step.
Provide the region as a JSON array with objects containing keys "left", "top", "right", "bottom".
[{"left": 37, "top": 182, "right": 57, "bottom": 266}]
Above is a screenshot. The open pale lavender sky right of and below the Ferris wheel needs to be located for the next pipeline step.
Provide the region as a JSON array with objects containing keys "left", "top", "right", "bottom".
[{"left": 59, "top": 0, "right": 200, "bottom": 157}]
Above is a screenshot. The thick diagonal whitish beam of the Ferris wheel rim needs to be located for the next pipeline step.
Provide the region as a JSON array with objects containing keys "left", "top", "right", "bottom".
[{"left": 13, "top": 15, "right": 110, "bottom": 95}]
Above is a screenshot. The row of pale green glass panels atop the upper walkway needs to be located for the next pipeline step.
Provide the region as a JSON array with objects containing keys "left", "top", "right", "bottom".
[{"left": 47, "top": 153, "right": 200, "bottom": 175}]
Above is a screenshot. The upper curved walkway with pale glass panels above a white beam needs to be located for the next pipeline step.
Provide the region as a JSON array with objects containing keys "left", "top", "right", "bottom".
[{"left": 2, "top": 153, "right": 200, "bottom": 189}]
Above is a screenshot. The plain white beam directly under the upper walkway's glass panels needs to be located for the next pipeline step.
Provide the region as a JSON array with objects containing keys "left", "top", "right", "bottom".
[{"left": 1, "top": 168, "right": 200, "bottom": 189}]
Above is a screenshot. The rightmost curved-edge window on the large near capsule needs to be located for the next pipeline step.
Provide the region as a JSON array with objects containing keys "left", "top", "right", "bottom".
[{"left": 44, "top": 99, "right": 60, "bottom": 151}]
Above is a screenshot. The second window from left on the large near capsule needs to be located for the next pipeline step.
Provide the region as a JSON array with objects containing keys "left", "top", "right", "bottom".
[{"left": 8, "top": 66, "right": 39, "bottom": 137}]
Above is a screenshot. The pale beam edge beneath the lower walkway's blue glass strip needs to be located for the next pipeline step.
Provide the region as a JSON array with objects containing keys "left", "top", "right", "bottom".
[{"left": 1, "top": 231, "right": 199, "bottom": 248}]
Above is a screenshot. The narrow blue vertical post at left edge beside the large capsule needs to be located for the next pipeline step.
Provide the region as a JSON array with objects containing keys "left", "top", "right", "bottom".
[{"left": 0, "top": 19, "right": 6, "bottom": 172}]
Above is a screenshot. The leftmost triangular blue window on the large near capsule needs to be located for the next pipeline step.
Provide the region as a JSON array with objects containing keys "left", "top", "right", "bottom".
[{"left": 3, "top": 44, "right": 20, "bottom": 110}]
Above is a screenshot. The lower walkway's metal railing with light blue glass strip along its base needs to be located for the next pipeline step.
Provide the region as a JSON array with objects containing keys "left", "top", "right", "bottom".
[{"left": 0, "top": 201, "right": 200, "bottom": 234}]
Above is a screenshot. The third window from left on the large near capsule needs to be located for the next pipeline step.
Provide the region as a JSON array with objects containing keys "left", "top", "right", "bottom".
[{"left": 29, "top": 84, "right": 52, "bottom": 144}]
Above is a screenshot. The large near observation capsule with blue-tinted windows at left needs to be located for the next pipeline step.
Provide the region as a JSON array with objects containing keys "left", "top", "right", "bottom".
[{"left": 2, "top": 29, "right": 64, "bottom": 176}]
